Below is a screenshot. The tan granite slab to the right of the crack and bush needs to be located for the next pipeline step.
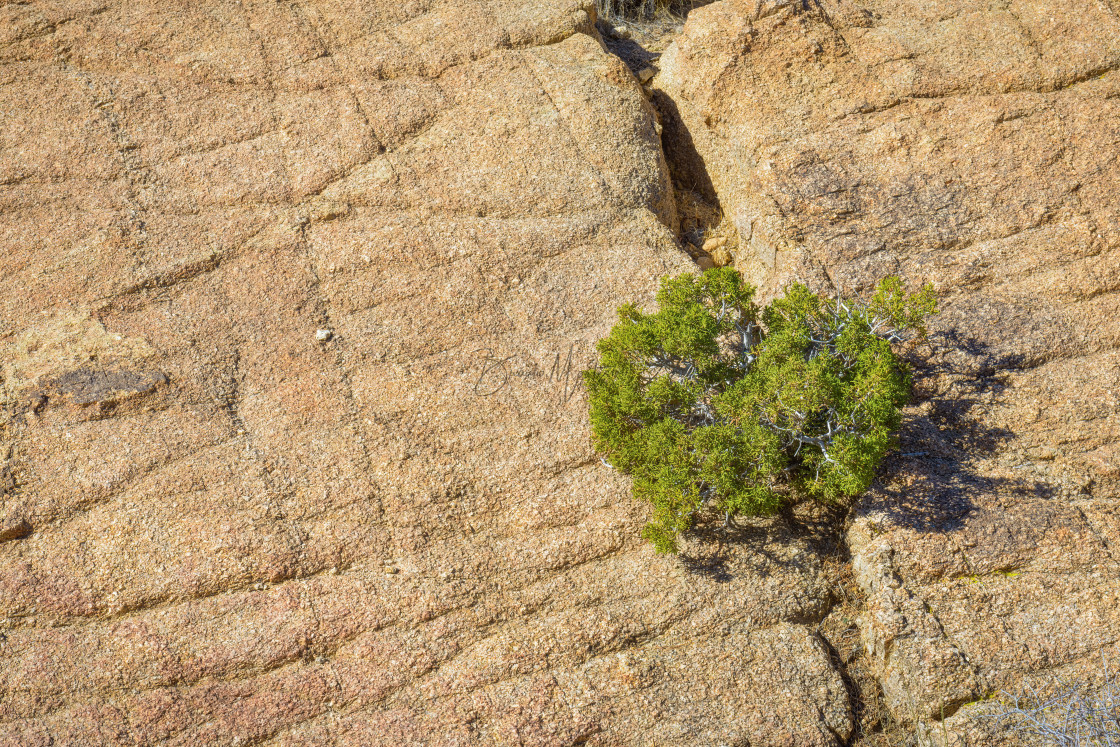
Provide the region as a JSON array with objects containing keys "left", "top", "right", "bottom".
[{"left": 654, "top": 0, "right": 1120, "bottom": 744}]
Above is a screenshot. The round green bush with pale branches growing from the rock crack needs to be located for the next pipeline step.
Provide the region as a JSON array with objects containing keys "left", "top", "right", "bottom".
[{"left": 584, "top": 268, "right": 936, "bottom": 552}]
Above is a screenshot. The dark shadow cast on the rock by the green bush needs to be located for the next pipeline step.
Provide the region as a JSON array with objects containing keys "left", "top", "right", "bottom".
[{"left": 680, "top": 330, "right": 1055, "bottom": 582}]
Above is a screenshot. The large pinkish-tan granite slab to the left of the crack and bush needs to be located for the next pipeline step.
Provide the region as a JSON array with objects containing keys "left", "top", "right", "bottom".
[{"left": 0, "top": 0, "right": 855, "bottom": 746}]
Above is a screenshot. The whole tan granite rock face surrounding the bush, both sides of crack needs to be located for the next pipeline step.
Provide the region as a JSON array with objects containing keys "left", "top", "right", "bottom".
[{"left": 0, "top": 0, "right": 1120, "bottom": 747}]
